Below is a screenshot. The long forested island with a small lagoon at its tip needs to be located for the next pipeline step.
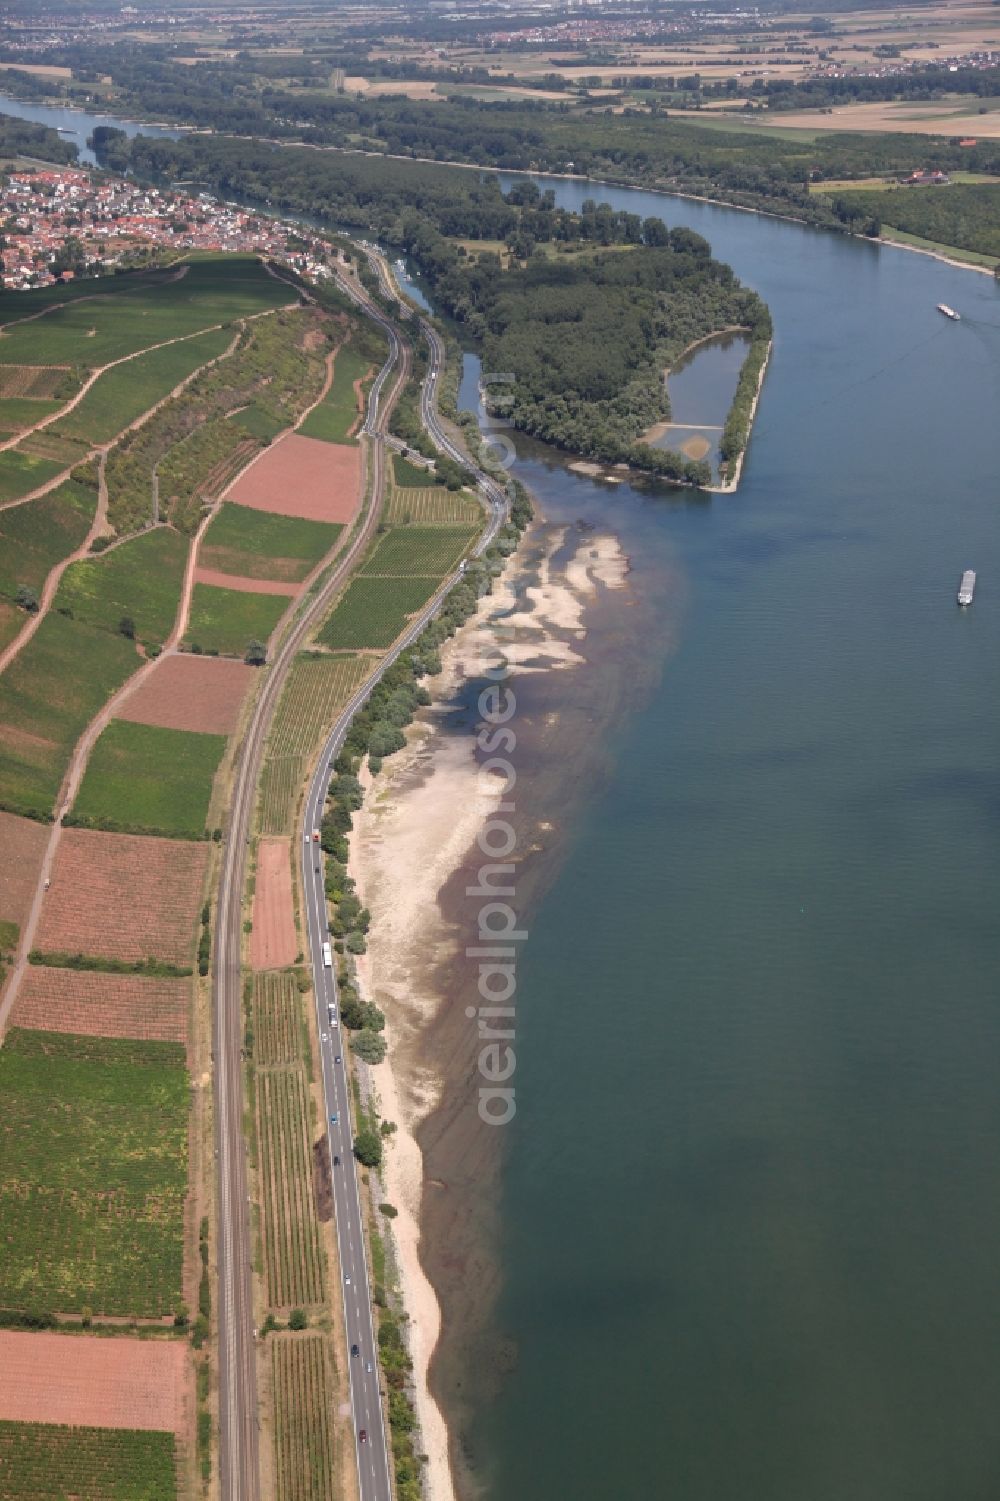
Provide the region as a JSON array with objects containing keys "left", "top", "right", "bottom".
[{"left": 93, "top": 132, "right": 770, "bottom": 485}]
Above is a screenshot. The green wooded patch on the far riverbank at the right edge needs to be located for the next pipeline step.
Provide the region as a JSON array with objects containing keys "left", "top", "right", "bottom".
[{"left": 833, "top": 183, "right": 1000, "bottom": 257}]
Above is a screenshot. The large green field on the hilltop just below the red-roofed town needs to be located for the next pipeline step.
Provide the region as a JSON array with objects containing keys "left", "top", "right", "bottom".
[{"left": 0, "top": 255, "right": 296, "bottom": 369}]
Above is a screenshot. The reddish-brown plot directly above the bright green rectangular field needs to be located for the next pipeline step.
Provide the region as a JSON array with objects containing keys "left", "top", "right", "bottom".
[{"left": 117, "top": 654, "right": 255, "bottom": 735}]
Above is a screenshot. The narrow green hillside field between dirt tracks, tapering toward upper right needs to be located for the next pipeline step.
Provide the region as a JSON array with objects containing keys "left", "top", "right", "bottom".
[{"left": 54, "top": 329, "right": 233, "bottom": 443}]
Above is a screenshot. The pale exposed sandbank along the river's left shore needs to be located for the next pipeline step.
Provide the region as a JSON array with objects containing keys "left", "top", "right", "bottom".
[{"left": 342, "top": 528, "right": 628, "bottom": 1501}]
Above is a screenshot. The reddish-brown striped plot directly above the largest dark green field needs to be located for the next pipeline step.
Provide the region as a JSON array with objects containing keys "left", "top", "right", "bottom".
[{"left": 12, "top": 964, "right": 191, "bottom": 1043}]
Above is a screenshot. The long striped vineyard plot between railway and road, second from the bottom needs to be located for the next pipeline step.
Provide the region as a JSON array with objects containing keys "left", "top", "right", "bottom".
[{"left": 255, "top": 1066, "right": 323, "bottom": 1309}]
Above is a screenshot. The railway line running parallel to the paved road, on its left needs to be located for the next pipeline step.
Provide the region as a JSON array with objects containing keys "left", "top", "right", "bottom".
[{"left": 212, "top": 258, "right": 410, "bottom": 1501}]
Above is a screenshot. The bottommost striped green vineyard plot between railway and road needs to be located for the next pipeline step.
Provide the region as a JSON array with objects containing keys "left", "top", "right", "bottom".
[{"left": 272, "top": 1334, "right": 336, "bottom": 1501}]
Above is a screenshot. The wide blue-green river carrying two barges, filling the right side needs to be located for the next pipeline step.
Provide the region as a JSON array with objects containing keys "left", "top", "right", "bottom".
[{"left": 7, "top": 96, "right": 1000, "bottom": 1501}]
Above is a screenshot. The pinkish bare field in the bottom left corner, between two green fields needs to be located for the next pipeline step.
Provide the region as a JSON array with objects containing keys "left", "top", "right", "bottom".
[{"left": 0, "top": 1330, "right": 189, "bottom": 1433}]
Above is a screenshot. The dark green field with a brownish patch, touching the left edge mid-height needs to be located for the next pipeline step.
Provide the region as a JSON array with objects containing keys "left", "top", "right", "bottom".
[{"left": 0, "top": 612, "right": 140, "bottom": 818}]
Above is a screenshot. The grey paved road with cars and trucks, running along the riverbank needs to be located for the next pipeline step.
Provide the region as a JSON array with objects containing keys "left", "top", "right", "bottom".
[{"left": 289, "top": 234, "right": 506, "bottom": 1501}]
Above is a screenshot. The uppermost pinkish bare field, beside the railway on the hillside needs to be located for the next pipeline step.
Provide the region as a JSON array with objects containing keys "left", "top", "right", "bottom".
[{"left": 227, "top": 432, "right": 360, "bottom": 522}]
